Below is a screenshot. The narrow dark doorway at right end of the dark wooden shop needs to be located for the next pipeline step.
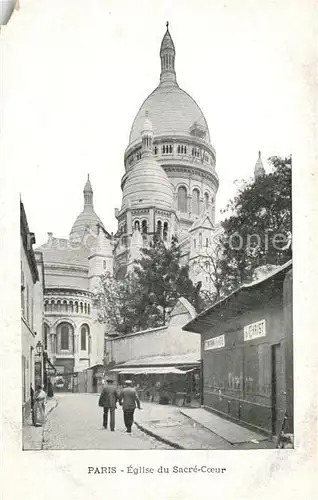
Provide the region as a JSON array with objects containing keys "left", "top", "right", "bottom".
[{"left": 272, "top": 344, "right": 285, "bottom": 436}]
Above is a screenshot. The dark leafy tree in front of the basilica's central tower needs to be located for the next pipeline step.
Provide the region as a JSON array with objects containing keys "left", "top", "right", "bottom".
[{"left": 134, "top": 237, "right": 198, "bottom": 328}]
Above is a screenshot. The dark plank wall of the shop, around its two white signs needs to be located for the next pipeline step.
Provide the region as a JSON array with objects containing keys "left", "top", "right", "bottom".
[{"left": 201, "top": 291, "right": 286, "bottom": 432}]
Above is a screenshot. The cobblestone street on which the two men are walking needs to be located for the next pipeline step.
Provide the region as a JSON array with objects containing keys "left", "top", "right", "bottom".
[{"left": 43, "top": 393, "right": 172, "bottom": 450}]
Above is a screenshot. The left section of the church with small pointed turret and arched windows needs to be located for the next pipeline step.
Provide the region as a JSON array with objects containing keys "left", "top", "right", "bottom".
[{"left": 39, "top": 178, "right": 113, "bottom": 378}]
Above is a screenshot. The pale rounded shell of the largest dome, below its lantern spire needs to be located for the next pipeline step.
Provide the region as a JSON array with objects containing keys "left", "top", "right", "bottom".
[{"left": 129, "top": 82, "right": 210, "bottom": 145}]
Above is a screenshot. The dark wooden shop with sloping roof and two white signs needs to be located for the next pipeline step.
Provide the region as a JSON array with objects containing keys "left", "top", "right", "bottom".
[{"left": 184, "top": 262, "right": 293, "bottom": 435}]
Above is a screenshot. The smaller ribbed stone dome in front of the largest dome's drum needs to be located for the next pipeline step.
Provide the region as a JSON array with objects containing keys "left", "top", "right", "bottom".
[{"left": 122, "top": 155, "right": 173, "bottom": 210}]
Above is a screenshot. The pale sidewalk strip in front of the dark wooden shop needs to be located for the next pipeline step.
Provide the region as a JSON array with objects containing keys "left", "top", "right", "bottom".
[{"left": 135, "top": 402, "right": 275, "bottom": 450}]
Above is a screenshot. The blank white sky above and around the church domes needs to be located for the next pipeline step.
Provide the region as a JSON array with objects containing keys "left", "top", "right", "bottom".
[{"left": 0, "top": 0, "right": 312, "bottom": 244}]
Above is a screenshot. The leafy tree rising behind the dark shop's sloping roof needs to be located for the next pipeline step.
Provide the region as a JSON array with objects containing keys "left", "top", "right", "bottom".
[{"left": 220, "top": 156, "right": 292, "bottom": 293}]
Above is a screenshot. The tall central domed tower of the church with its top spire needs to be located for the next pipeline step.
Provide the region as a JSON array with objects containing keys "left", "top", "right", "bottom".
[{"left": 114, "top": 24, "right": 219, "bottom": 277}]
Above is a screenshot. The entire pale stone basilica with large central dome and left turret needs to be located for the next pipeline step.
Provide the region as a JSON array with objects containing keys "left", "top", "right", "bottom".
[{"left": 37, "top": 23, "right": 261, "bottom": 374}]
